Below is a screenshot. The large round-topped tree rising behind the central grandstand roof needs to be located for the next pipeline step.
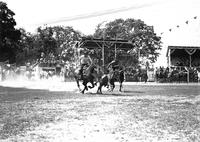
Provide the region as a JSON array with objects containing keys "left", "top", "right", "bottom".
[{"left": 94, "top": 19, "right": 161, "bottom": 66}]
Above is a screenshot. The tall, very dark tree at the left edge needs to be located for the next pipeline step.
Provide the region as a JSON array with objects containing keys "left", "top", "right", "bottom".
[{"left": 0, "top": 1, "right": 20, "bottom": 63}]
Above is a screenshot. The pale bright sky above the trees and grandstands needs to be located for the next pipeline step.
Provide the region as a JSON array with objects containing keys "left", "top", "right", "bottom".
[{"left": 3, "top": 0, "right": 200, "bottom": 66}]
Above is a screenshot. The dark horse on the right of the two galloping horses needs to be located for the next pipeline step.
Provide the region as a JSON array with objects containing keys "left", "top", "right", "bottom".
[{"left": 97, "top": 67, "right": 125, "bottom": 94}]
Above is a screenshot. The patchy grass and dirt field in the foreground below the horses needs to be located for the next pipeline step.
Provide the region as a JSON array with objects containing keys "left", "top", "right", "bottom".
[{"left": 0, "top": 81, "right": 200, "bottom": 142}]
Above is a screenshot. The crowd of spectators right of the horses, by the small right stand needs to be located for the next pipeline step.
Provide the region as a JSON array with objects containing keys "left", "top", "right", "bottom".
[{"left": 126, "top": 66, "right": 200, "bottom": 83}]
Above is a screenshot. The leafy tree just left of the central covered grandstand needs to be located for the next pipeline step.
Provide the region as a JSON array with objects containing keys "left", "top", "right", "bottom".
[{"left": 37, "top": 26, "right": 81, "bottom": 61}]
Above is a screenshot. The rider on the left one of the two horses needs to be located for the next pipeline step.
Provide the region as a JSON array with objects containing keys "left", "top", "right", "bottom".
[{"left": 79, "top": 51, "right": 92, "bottom": 79}]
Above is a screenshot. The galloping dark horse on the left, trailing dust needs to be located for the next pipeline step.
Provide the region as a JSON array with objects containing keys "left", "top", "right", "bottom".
[{"left": 71, "top": 64, "right": 97, "bottom": 94}]
